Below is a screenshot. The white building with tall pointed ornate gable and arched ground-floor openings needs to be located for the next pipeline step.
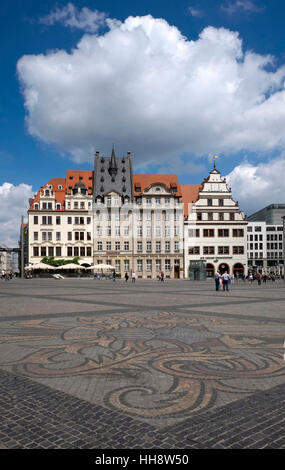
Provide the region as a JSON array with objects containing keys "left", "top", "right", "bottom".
[{"left": 182, "top": 165, "right": 247, "bottom": 279}]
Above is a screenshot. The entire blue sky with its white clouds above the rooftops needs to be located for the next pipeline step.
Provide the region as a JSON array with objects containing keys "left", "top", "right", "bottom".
[{"left": 0, "top": 0, "right": 285, "bottom": 246}]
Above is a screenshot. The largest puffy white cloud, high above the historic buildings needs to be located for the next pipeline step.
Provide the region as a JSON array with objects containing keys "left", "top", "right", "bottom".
[{"left": 17, "top": 15, "right": 285, "bottom": 165}]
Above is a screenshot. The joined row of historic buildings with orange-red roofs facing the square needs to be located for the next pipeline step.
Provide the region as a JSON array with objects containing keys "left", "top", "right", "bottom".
[{"left": 28, "top": 148, "right": 247, "bottom": 279}]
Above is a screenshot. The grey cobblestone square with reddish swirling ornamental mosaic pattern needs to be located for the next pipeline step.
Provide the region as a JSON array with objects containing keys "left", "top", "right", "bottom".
[{"left": 0, "top": 279, "right": 285, "bottom": 449}]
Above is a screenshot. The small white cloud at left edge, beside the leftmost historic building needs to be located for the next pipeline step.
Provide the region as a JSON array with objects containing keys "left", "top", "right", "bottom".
[{"left": 0, "top": 182, "right": 34, "bottom": 248}]
